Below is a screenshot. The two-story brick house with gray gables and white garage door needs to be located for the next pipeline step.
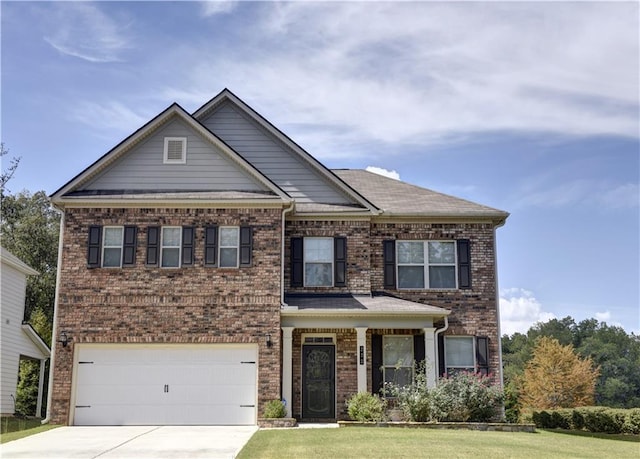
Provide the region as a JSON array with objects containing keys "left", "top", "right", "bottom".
[{"left": 49, "top": 90, "right": 508, "bottom": 425}]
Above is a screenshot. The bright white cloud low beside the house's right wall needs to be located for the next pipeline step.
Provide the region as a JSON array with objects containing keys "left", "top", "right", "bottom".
[{"left": 500, "top": 288, "right": 556, "bottom": 335}]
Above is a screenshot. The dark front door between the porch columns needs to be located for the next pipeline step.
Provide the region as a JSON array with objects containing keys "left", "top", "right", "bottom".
[{"left": 302, "top": 344, "right": 336, "bottom": 419}]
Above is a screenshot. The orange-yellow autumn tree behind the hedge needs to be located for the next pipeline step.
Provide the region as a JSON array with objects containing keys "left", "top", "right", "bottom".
[{"left": 519, "top": 336, "right": 600, "bottom": 409}]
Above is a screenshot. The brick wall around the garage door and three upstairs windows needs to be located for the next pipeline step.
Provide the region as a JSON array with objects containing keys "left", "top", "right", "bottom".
[{"left": 51, "top": 209, "right": 282, "bottom": 424}]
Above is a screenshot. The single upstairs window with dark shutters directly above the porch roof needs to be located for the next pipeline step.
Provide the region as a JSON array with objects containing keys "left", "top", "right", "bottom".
[{"left": 291, "top": 237, "right": 347, "bottom": 287}]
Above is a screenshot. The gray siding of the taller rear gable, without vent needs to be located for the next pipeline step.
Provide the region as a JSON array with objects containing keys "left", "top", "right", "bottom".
[{"left": 200, "top": 101, "right": 357, "bottom": 205}]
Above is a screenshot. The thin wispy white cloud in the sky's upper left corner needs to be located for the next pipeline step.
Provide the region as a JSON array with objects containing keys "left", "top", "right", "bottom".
[{"left": 43, "top": 2, "right": 130, "bottom": 63}]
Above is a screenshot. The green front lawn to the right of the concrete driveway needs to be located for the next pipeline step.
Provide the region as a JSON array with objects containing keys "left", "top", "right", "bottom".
[{"left": 238, "top": 427, "right": 640, "bottom": 459}]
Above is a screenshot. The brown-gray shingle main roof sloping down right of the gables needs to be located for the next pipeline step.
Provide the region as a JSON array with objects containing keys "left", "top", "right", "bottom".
[{"left": 332, "top": 169, "right": 509, "bottom": 221}]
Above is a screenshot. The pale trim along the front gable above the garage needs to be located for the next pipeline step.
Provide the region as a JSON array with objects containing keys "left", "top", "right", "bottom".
[{"left": 51, "top": 103, "right": 291, "bottom": 204}]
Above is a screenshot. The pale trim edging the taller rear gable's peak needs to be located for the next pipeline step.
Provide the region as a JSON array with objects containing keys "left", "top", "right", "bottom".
[{"left": 193, "top": 88, "right": 380, "bottom": 215}]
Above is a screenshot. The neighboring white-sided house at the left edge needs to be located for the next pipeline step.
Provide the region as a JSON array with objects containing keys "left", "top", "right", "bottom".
[{"left": 0, "top": 247, "right": 51, "bottom": 415}]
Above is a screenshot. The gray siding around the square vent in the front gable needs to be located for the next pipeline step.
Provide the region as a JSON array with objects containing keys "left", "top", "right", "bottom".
[{"left": 79, "top": 116, "right": 267, "bottom": 191}]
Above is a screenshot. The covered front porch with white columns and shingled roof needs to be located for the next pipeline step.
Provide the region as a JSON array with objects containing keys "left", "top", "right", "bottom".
[{"left": 281, "top": 295, "right": 449, "bottom": 422}]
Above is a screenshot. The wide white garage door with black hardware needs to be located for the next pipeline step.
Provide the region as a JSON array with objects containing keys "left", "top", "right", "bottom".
[{"left": 73, "top": 345, "right": 257, "bottom": 425}]
